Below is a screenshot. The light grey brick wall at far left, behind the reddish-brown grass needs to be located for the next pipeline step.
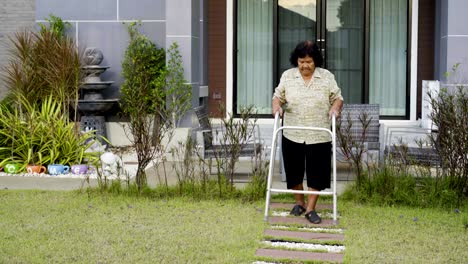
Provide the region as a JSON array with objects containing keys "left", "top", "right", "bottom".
[{"left": 0, "top": 0, "right": 36, "bottom": 98}]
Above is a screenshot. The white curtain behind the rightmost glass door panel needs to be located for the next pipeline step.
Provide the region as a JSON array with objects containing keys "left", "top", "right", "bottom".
[{"left": 369, "top": 0, "right": 408, "bottom": 116}]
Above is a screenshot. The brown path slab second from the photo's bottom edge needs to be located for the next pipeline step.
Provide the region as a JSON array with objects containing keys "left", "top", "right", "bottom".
[{"left": 264, "top": 229, "right": 344, "bottom": 241}]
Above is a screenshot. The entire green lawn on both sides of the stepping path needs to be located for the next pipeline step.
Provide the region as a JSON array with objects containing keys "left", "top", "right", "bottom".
[{"left": 0, "top": 190, "right": 468, "bottom": 263}]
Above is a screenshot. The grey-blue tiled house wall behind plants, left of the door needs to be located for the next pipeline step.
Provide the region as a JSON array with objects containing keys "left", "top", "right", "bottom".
[{"left": 35, "top": 0, "right": 207, "bottom": 145}]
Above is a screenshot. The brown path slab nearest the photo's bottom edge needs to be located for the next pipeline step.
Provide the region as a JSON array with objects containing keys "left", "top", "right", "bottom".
[{"left": 255, "top": 248, "right": 343, "bottom": 263}]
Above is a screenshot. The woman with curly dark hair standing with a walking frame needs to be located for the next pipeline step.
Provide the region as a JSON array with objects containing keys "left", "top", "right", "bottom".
[{"left": 272, "top": 41, "right": 343, "bottom": 224}]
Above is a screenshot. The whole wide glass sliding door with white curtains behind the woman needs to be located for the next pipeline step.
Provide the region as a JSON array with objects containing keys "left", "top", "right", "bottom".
[{"left": 233, "top": 0, "right": 409, "bottom": 118}]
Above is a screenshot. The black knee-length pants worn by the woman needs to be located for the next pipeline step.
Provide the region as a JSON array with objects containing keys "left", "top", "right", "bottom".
[{"left": 281, "top": 136, "right": 332, "bottom": 191}]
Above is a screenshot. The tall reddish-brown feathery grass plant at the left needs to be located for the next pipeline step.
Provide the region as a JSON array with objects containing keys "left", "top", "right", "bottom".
[{"left": 2, "top": 15, "right": 84, "bottom": 113}]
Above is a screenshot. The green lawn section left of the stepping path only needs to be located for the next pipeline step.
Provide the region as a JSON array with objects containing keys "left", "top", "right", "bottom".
[{"left": 0, "top": 191, "right": 264, "bottom": 263}]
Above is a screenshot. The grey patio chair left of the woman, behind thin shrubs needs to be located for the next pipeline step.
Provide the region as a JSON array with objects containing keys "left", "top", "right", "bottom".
[{"left": 194, "top": 106, "right": 264, "bottom": 172}]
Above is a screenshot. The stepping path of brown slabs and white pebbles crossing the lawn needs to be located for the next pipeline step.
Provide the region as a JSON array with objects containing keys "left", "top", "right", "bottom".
[{"left": 255, "top": 203, "right": 345, "bottom": 263}]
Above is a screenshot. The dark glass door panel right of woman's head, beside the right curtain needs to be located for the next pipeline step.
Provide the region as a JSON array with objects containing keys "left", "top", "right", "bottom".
[{"left": 324, "top": 0, "right": 364, "bottom": 103}]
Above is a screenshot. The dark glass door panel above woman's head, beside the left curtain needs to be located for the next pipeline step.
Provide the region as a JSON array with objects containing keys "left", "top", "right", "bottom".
[{"left": 277, "top": 0, "right": 317, "bottom": 81}]
